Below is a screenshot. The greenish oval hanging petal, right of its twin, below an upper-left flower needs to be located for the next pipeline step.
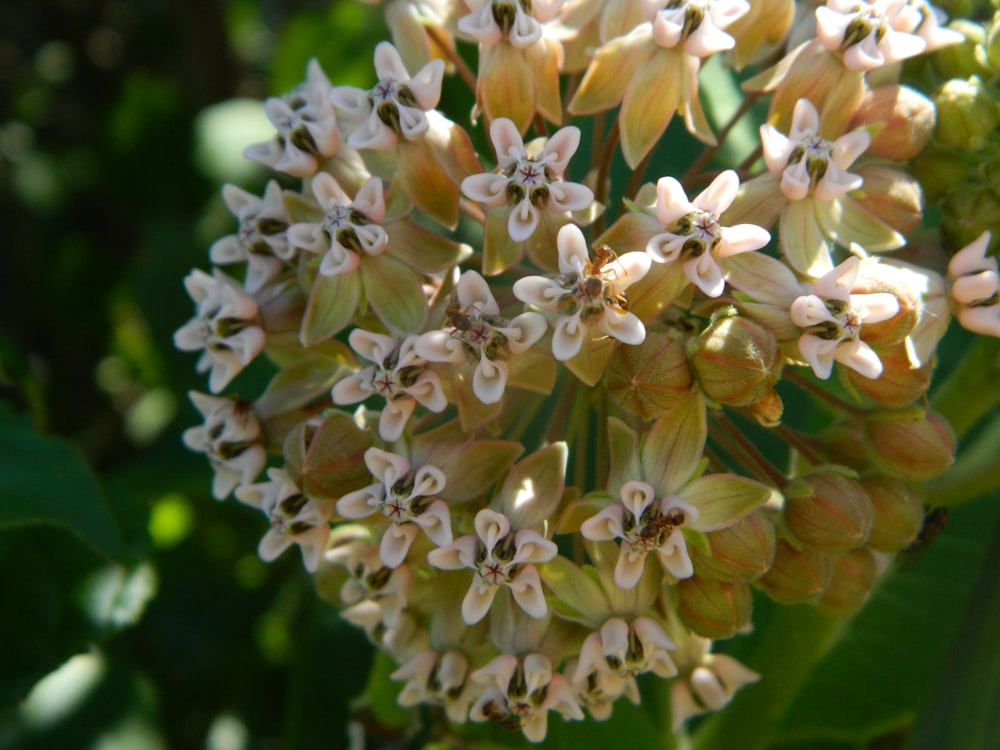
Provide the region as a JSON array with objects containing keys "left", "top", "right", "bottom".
[{"left": 361, "top": 254, "right": 427, "bottom": 333}]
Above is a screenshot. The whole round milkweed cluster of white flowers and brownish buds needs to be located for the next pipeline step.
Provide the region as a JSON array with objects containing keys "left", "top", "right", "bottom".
[{"left": 174, "top": 0, "right": 1000, "bottom": 742}]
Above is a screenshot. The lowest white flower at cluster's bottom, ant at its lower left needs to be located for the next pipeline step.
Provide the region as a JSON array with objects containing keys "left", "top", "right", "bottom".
[{"left": 469, "top": 653, "right": 583, "bottom": 742}]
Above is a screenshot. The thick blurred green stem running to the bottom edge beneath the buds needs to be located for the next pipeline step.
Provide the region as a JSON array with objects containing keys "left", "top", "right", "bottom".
[{"left": 692, "top": 605, "right": 848, "bottom": 750}]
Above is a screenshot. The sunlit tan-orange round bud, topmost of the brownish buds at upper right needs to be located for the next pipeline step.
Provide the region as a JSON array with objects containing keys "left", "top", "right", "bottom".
[{"left": 847, "top": 86, "right": 935, "bottom": 161}]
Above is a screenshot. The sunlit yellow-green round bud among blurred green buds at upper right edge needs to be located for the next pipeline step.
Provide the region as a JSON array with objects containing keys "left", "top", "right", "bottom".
[{"left": 934, "top": 76, "right": 1000, "bottom": 151}]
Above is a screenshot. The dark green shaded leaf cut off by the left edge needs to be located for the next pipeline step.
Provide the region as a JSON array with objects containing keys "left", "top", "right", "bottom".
[{"left": 0, "top": 423, "right": 125, "bottom": 561}]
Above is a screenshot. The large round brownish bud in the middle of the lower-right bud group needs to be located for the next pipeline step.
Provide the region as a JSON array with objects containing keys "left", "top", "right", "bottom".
[{"left": 784, "top": 466, "right": 872, "bottom": 554}]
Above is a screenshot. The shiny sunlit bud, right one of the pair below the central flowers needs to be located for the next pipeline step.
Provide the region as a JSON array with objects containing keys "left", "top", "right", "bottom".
[{"left": 687, "top": 307, "right": 781, "bottom": 406}]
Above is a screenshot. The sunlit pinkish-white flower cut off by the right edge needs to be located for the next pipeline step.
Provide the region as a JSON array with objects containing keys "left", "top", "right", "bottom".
[{"left": 948, "top": 232, "right": 1000, "bottom": 336}]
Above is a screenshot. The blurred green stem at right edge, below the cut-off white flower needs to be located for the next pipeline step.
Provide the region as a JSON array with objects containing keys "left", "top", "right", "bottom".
[{"left": 931, "top": 336, "right": 1000, "bottom": 437}]
